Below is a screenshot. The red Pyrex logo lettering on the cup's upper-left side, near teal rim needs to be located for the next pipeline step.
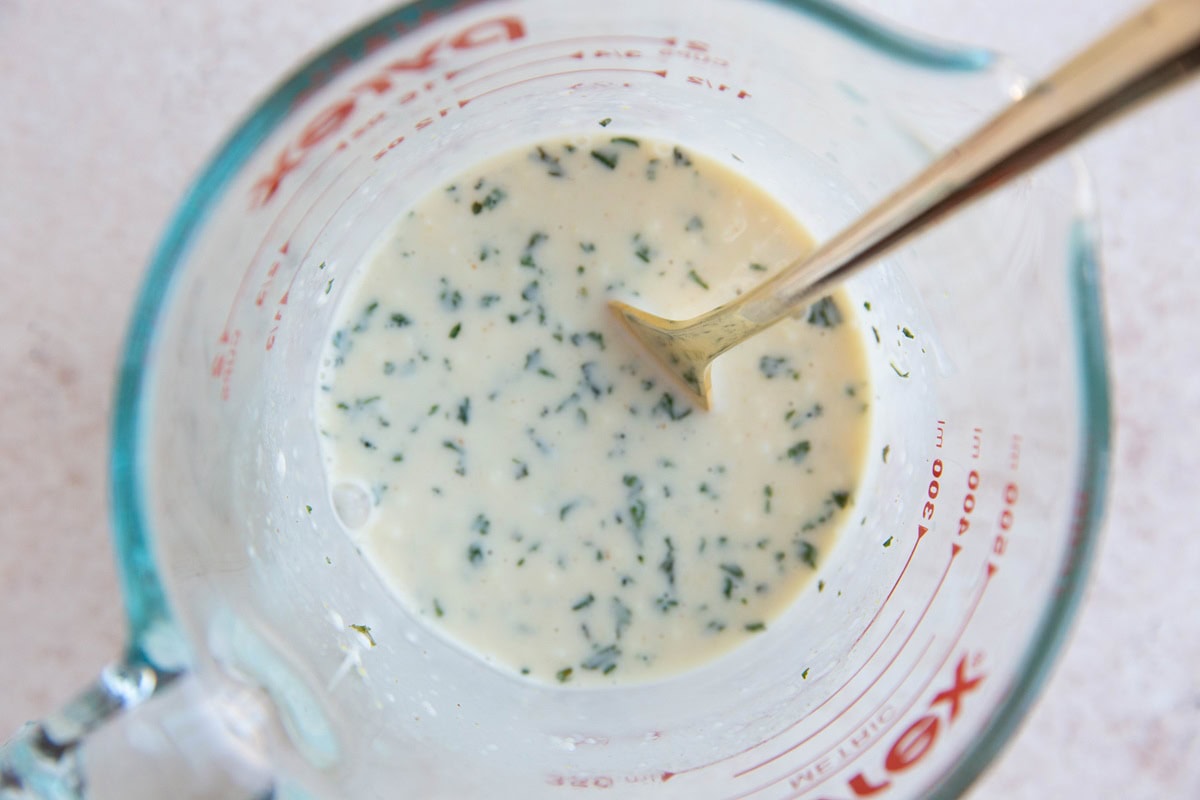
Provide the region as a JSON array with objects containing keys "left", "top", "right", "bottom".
[{"left": 251, "top": 17, "right": 526, "bottom": 207}]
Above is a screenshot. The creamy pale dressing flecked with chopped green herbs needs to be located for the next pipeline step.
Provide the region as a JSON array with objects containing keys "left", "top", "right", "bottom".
[{"left": 316, "top": 132, "right": 870, "bottom": 686}]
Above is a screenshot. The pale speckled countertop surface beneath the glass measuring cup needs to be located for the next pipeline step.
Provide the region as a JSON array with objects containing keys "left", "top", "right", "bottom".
[{"left": 0, "top": 0, "right": 1200, "bottom": 800}]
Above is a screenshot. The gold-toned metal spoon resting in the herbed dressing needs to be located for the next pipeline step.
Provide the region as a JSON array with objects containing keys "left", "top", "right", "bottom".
[{"left": 611, "top": 0, "right": 1200, "bottom": 409}]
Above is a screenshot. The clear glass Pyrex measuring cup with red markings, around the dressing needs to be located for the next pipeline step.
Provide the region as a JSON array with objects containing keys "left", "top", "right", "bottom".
[{"left": 0, "top": 0, "right": 1108, "bottom": 800}]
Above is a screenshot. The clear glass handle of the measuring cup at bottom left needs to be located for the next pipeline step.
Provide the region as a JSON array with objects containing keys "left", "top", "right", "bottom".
[{"left": 0, "top": 663, "right": 271, "bottom": 800}]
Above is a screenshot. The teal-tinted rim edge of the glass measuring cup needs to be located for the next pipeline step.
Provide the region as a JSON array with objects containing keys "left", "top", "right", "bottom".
[{"left": 109, "top": 0, "right": 1111, "bottom": 799}]
